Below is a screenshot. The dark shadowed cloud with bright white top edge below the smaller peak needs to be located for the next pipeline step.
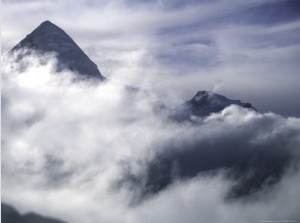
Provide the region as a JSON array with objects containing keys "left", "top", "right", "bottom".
[{"left": 119, "top": 106, "right": 300, "bottom": 202}]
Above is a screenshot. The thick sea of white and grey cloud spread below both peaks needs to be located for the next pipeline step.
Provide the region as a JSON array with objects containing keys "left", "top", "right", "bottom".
[{"left": 1, "top": 51, "right": 300, "bottom": 223}]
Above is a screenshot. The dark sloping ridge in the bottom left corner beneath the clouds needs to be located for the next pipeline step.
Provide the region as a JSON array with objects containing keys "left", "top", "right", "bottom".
[{"left": 1, "top": 203, "right": 65, "bottom": 223}]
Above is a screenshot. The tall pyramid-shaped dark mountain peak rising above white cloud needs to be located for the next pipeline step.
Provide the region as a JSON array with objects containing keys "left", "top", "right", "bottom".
[{"left": 10, "top": 21, "right": 105, "bottom": 80}]
